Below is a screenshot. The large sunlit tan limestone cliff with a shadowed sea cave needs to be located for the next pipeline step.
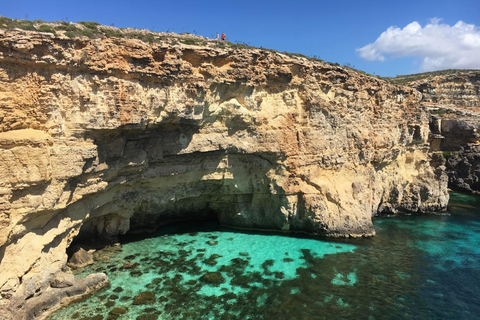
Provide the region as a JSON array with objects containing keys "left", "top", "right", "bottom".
[{"left": 0, "top": 30, "right": 448, "bottom": 318}]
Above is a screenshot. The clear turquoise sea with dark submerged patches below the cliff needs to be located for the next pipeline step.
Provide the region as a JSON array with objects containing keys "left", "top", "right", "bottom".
[{"left": 49, "top": 194, "right": 480, "bottom": 320}]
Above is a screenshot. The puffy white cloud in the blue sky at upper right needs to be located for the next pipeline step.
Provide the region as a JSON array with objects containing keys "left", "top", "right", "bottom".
[{"left": 357, "top": 18, "right": 480, "bottom": 71}]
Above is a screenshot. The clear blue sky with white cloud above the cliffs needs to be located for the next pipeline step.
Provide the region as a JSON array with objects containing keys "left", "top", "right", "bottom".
[{"left": 0, "top": 0, "right": 480, "bottom": 76}]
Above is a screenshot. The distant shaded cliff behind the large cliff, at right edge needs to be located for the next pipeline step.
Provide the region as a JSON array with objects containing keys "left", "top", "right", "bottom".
[{"left": 396, "top": 70, "right": 480, "bottom": 193}]
